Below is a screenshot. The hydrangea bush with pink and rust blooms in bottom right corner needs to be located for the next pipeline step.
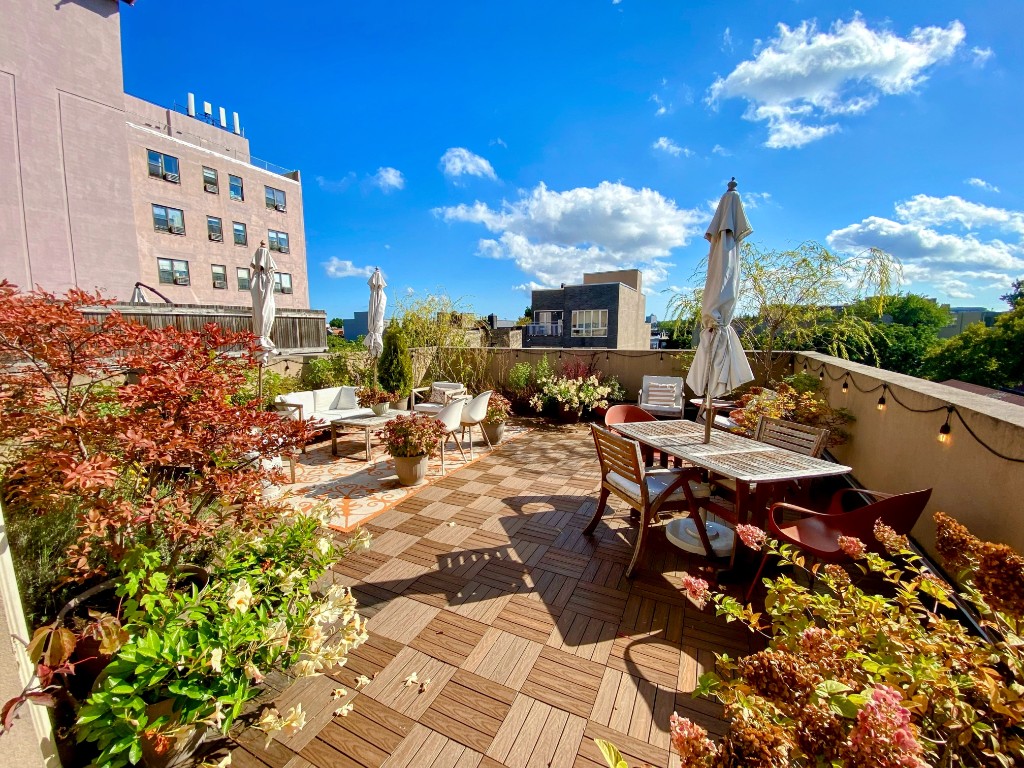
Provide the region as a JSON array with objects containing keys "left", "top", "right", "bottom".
[{"left": 670, "top": 513, "right": 1024, "bottom": 768}]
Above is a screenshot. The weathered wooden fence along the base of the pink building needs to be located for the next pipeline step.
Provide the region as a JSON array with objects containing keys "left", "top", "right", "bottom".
[{"left": 86, "top": 303, "right": 327, "bottom": 353}]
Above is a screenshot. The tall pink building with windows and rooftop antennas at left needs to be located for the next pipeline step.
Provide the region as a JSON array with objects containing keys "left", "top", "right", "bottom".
[{"left": 0, "top": 0, "right": 309, "bottom": 309}]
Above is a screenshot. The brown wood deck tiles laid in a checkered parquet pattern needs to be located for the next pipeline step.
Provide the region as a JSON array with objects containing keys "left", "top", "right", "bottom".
[{"left": 231, "top": 426, "right": 756, "bottom": 768}]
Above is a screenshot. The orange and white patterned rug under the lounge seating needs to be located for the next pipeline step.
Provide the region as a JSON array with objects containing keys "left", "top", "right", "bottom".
[{"left": 284, "top": 424, "right": 530, "bottom": 532}]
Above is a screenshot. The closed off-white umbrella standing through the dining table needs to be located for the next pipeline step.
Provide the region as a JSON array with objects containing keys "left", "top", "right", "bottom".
[{"left": 686, "top": 177, "right": 754, "bottom": 442}]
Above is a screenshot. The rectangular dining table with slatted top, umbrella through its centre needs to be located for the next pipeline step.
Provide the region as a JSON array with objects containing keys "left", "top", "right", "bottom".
[{"left": 614, "top": 419, "right": 853, "bottom": 528}]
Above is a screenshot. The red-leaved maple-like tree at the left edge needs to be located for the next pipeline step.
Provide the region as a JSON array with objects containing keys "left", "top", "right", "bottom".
[{"left": 0, "top": 281, "right": 307, "bottom": 578}]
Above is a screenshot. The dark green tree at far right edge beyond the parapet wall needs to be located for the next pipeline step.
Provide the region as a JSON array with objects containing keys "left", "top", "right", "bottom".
[{"left": 923, "top": 302, "right": 1024, "bottom": 387}]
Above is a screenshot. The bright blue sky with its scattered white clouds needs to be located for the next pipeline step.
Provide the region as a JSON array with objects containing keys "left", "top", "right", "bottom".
[{"left": 121, "top": 0, "right": 1024, "bottom": 317}]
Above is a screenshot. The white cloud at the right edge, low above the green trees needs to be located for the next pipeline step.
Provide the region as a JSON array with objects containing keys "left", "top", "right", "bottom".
[{"left": 827, "top": 195, "right": 1024, "bottom": 304}]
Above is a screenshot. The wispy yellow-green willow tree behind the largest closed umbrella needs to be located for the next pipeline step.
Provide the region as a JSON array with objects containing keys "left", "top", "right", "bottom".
[{"left": 669, "top": 242, "right": 902, "bottom": 381}]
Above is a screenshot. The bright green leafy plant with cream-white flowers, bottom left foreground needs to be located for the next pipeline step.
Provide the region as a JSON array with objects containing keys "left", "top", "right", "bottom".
[{"left": 12, "top": 515, "right": 369, "bottom": 768}]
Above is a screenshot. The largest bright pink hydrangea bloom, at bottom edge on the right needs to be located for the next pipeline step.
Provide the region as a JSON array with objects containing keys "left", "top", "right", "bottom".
[{"left": 847, "top": 685, "right": 928, "bottom": 768}]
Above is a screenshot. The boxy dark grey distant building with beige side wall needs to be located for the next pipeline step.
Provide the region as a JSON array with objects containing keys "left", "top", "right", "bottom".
[{"left": 523, "top": 269, "right": 650, "bottom": 349}]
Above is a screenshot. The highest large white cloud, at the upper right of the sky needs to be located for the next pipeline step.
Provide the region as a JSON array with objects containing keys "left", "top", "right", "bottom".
[{"left": 708, "top": 15, "right": 966, "bottom": 148}]
